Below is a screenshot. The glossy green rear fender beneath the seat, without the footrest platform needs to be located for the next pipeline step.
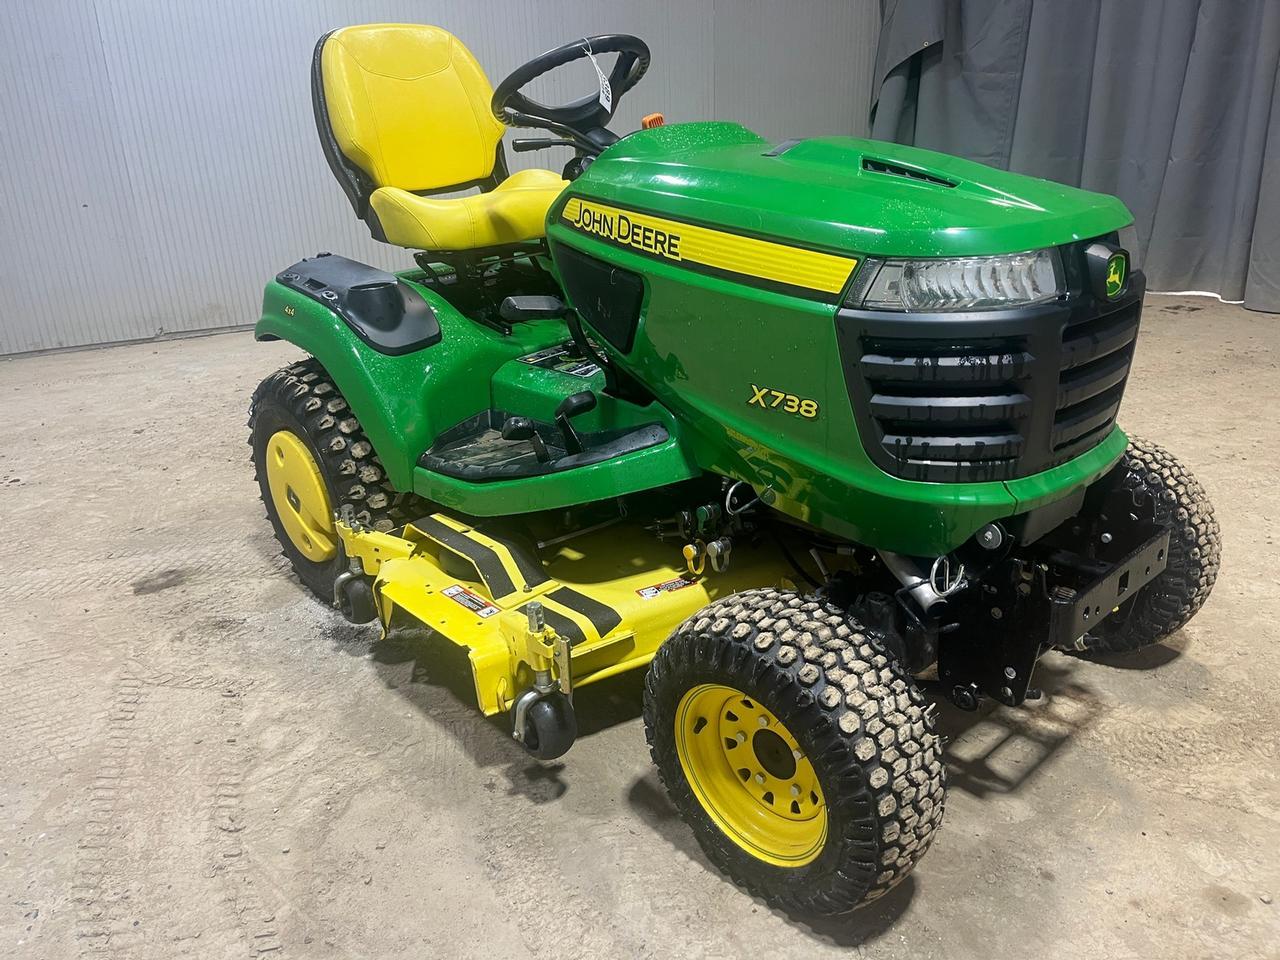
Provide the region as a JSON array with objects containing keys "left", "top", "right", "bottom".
[{"left": 255, "top": 278, "right": 567, "bottom": 490}]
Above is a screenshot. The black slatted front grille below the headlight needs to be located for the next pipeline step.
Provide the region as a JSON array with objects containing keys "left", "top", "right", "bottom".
[{"left": 836, "top": 274, "right": 1142, "bottom": 481}]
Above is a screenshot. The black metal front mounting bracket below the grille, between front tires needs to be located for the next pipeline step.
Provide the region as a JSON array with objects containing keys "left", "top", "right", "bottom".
[{"left": 938, "top": 522, "right": 1169, "bottom": 708}]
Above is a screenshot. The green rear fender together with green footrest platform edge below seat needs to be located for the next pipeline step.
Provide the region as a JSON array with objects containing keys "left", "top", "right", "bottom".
[{"left": 255, "top": 276, "right": 699, "bottom": 516}]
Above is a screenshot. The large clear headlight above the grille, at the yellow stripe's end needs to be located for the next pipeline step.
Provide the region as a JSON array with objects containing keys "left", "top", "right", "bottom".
[{"left": 851, "top": 247, "right": 1062, "bottom": 312}]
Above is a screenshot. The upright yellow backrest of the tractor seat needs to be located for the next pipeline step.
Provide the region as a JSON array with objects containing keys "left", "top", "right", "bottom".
[{"left": 320, "top": 23, "right": 504, "bottom": 192}]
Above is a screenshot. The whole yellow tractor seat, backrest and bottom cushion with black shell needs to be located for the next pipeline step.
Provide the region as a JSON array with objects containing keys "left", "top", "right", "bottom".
[{"left": 312, "top": 23, "right": 566, "bottom": 251}]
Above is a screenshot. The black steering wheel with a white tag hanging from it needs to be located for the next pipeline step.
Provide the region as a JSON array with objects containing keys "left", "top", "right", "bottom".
[{"left": 490, "top": 33, "right": 649, "bottom": 154}]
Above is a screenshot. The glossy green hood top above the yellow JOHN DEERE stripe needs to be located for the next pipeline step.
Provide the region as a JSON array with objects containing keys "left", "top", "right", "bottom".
[{"left": 568, "top": 123, "right": 1133, "bottom": 256}]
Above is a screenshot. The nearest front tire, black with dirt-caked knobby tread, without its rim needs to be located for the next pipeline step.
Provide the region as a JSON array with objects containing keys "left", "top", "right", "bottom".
[{"left": 644, "top": 589, "right": 946, "bottom": 915}]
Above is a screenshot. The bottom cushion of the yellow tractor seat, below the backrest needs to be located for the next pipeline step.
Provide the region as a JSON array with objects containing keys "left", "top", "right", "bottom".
[{"left": 370, "top": 170, "right": 567, "bottom": 250}]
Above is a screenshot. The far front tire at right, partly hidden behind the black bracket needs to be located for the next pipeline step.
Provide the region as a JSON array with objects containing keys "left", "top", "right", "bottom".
[{"left": 1068, "top": 436, "right": 1222, "bottom": 655}]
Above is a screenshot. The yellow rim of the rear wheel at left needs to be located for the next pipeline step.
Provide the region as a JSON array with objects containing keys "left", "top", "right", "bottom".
[{"left": 266, "top": 430, "right": 338, "bottom": 563}]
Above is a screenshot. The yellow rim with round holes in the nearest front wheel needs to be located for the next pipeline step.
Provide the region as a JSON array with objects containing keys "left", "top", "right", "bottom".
[{"left": 676, "top": 684, "right": 827, "bottom": 867}]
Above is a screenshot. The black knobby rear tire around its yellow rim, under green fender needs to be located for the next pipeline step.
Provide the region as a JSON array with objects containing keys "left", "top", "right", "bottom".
[{"left": 248, "top": 357, "right": 426, "bottom": 603}]
